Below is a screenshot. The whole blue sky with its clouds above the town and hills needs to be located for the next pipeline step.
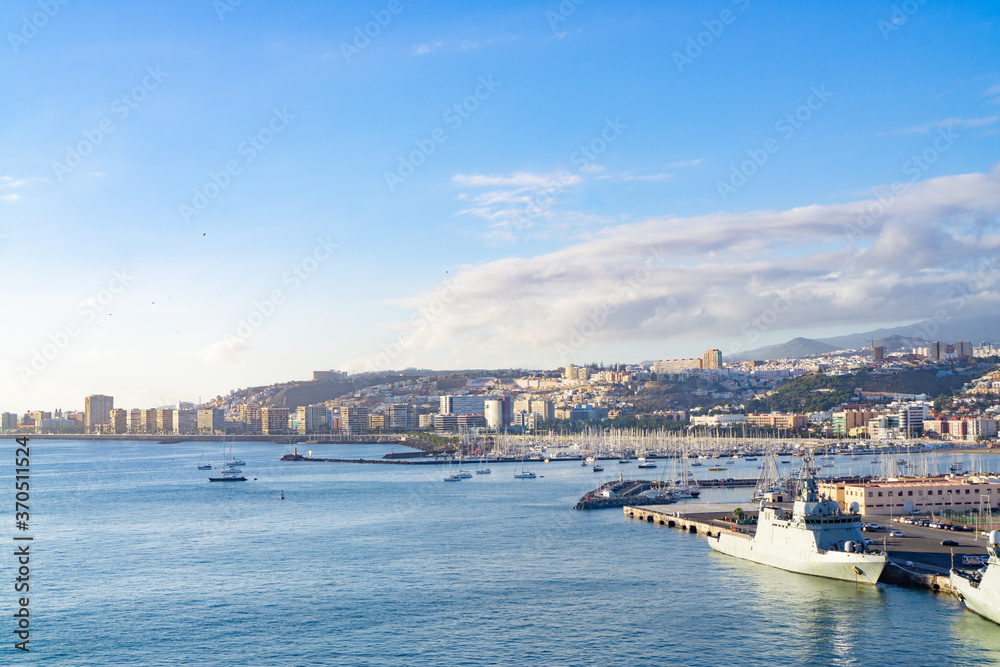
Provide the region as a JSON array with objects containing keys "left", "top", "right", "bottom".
[{"left": 0, "top": 0, "right": 1000, "bottom": 411}]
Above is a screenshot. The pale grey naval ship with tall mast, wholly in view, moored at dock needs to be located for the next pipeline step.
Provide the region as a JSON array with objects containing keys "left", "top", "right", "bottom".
[{"left": 708, "top": 453, "right": 886, "bottom": 584}]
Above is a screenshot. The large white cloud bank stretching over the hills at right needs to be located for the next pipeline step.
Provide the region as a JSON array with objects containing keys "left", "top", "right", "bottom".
[{"left": 388, "top": 166, "right": 1000, "bottom": 367}]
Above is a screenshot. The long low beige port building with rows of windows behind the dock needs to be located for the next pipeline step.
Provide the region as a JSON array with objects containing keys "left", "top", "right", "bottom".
[{"left": 819, "top": 476, "right": 1000, "bottom": 515}]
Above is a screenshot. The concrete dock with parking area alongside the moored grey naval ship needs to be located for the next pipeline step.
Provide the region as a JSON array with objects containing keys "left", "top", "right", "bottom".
[{"left": 623, "top": 503, "right": 986, "bottom": 591}]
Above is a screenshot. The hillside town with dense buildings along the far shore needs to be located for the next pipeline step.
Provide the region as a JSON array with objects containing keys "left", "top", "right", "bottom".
[{"left": 2, "top": 342, "right": 1000, "bottom": 445}]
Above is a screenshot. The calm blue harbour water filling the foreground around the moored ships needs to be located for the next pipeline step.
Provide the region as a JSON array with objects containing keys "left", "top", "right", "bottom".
[{"left": 0, "top": 440, "right": 1000, "bottom": 665}]
